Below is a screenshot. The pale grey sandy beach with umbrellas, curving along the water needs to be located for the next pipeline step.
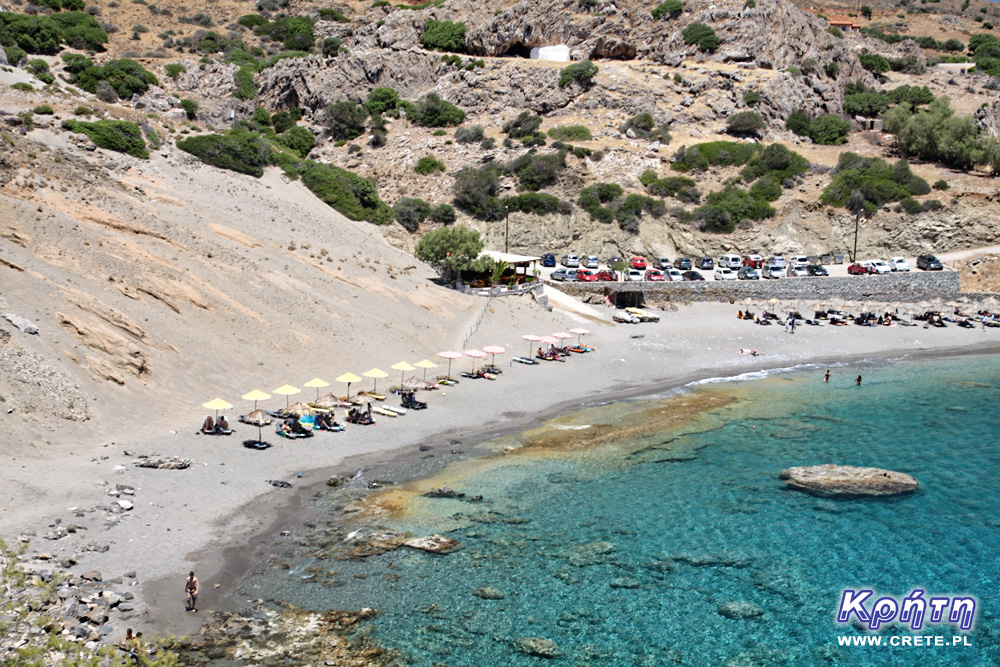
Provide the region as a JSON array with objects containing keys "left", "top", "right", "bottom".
[{"left": 0, "top": 290, "right": 1000, "bottom": 648}]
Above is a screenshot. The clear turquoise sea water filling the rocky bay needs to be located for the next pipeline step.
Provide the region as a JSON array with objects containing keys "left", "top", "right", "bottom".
[{"left": 240, "top": 356, "right": 1000, "bottom": 667}]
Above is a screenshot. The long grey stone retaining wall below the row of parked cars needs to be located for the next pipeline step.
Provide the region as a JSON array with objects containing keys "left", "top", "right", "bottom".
[{"left": 548, "top": 271, "right": 960, "bottom": 303}]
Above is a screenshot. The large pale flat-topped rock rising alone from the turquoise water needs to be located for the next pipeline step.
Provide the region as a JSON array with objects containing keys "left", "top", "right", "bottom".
[{"left": 778, "top": 463, "right": 920, "bottom": 496}]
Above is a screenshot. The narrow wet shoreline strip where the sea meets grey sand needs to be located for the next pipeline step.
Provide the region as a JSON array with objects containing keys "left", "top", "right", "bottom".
[{"left": 144, "top": 343, "right": 1000, "bottom": 636}]
